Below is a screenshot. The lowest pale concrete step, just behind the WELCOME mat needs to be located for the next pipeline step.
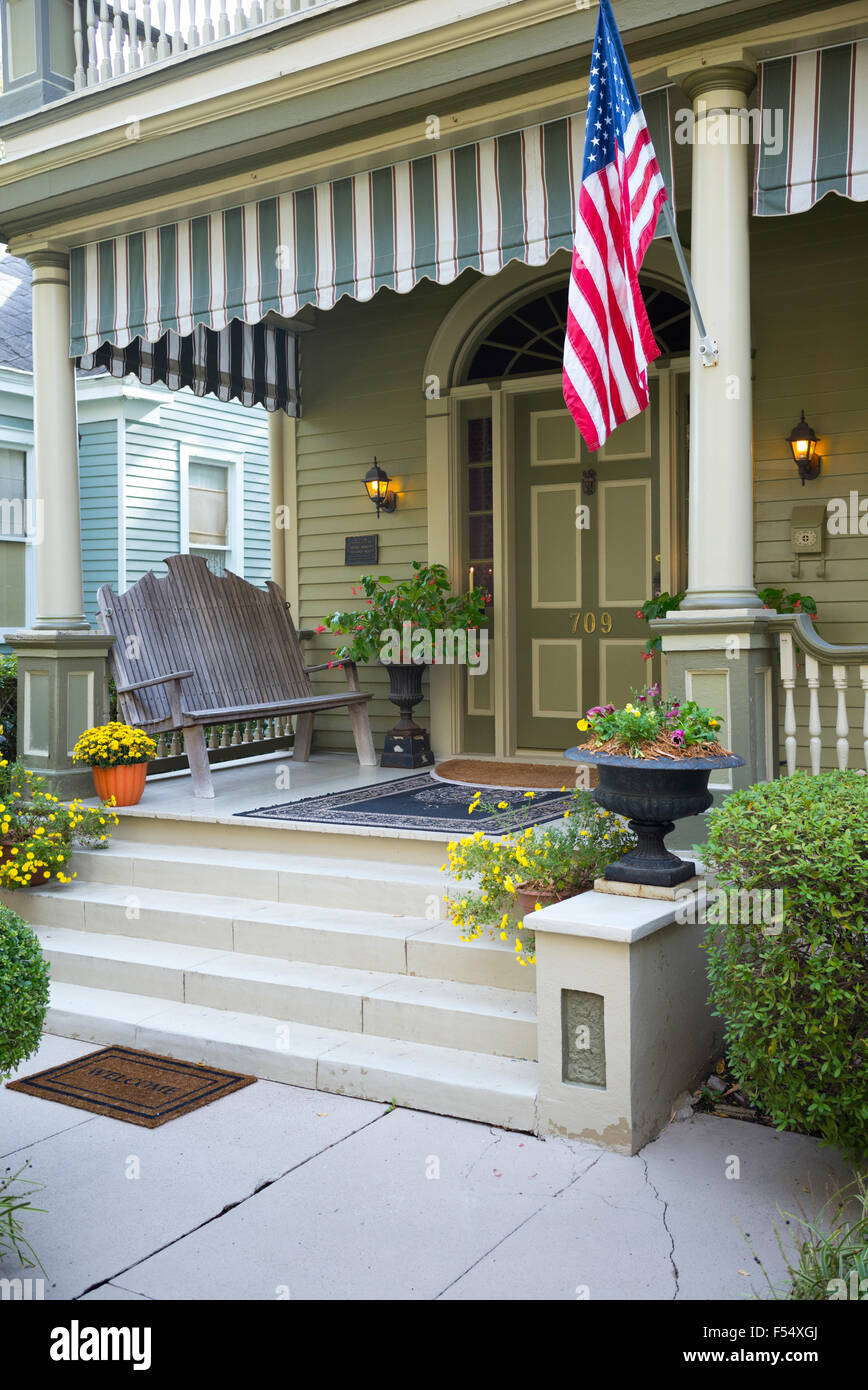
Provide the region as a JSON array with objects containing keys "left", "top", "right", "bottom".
[{"left": 46, "top": 979, "right": 537, "bottom": 1133}]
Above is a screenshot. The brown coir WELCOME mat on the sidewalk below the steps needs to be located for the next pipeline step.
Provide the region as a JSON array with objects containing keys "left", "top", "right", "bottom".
[{"left": 7, "top": 1047, "right": 256, "bottom": 1129}]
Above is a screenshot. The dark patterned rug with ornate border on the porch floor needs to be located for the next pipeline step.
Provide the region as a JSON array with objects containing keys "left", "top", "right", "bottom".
[{"left": 236, "top": 773, "right": 572, "bottom": 835}]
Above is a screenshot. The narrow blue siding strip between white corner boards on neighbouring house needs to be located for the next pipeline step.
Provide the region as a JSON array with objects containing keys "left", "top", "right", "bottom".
[{"left": 78, "top": 420, "right": 118, "bottom": 620}]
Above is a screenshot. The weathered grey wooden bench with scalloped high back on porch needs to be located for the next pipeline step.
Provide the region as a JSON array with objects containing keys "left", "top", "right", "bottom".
[{"left": 99, "top": 555, "right": 377, "bottom": 796}]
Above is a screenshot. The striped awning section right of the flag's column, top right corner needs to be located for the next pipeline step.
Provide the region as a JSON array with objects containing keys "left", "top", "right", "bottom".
[{"left": 754, "top": 39, "right": 868, "bottom": 217}]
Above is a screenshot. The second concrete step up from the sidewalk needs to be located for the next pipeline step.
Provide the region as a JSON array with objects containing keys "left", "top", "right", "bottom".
[{"left": 36, "top": 927, "right": 537, "bottom": 1059}]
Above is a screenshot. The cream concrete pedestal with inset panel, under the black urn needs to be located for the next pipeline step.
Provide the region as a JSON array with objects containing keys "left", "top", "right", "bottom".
[{"left": 536, "top": 890, "right": 721, "bottom": 1154}]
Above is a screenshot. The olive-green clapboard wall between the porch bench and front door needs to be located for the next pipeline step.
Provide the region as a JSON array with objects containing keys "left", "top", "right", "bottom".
[{"left": 296, "top": 278, "right": 467, "bottom": 748}]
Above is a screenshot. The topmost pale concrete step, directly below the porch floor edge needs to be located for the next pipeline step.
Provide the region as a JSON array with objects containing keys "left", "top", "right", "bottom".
[{"left": 71, "top": 839, "right": 449, "bottom": 920}]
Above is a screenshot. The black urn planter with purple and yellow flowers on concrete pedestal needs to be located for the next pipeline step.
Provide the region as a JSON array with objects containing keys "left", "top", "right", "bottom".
[{"left": 566, "top": 685, "right": 744, "bottom": 888}]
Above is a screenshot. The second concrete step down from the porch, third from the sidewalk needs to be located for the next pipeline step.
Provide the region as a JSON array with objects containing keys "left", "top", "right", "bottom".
[{"left": 10, "top": 884, "right": 536, "bottom": 992}]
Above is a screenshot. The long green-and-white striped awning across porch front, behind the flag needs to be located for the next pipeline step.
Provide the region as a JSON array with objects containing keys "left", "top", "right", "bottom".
[{"left": 71, "top": 88, "right": 673, "bottom": 356}]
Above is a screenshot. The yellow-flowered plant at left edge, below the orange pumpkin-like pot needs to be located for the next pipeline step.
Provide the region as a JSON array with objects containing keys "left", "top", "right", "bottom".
[{"left": 0, "top": 728, "right": 117, "bottom": 890}]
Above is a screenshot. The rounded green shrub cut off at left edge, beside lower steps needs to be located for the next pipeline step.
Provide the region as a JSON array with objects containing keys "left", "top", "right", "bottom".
[{"left": 0, "top": 906, "right": 49, "bottom": 1077}]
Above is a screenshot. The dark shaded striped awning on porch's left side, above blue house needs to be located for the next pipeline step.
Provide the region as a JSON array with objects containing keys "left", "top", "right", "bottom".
[{"left": 78, "top": 318, "right": 299, "bottom": 416}]
